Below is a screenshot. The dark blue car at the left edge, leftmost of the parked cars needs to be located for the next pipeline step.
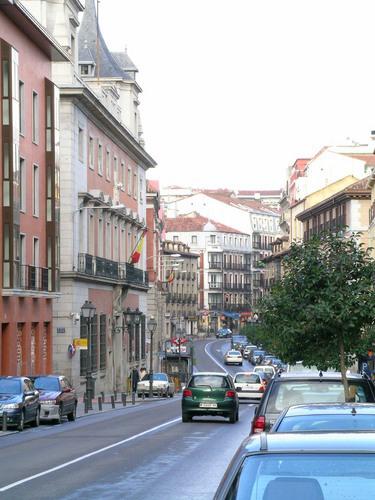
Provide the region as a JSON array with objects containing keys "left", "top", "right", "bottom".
[{"left": 0, "top": 377, "right": 40, "bottom": 431}]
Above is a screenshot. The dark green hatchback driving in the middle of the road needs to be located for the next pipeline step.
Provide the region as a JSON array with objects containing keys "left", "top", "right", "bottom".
[{"left": 182, "top": 372, "right": 239, "bottom": 424}]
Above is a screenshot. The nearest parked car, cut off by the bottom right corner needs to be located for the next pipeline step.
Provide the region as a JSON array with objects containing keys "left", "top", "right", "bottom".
[{"left": 214, "top": 432, "right": 375, "bottom": 500}]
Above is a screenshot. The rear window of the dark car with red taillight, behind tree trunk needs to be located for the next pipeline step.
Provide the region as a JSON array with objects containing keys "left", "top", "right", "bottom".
[{"left": 267, "top": 380, "right": 374, "bottom": 413}]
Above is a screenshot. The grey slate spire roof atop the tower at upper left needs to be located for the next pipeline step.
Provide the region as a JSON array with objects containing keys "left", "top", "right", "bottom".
[{"left": 78, "top": 0, "right": 135, "bottom": 80}]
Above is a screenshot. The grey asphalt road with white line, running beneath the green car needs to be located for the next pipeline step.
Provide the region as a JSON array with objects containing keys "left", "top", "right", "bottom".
[{"left": 0, "top": 340, "right": 254, "bottom": 500}]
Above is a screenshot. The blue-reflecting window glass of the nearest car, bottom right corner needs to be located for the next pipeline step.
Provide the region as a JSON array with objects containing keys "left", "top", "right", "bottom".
[{"left": 235, "top": 453, "right": 375, "bottom": 500}]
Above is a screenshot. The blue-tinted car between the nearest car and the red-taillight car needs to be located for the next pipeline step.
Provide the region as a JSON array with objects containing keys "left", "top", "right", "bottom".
[{"left": 271, "top": 403, "right": 375, "bottom": 432}]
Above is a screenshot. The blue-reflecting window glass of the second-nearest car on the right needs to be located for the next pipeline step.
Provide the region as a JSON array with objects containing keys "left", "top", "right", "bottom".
[{"left": 276, "top": 412, "right": 375, "bottom": 432}]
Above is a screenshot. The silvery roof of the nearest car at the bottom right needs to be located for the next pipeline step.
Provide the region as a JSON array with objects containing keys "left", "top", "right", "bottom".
[{"left": 241, "top": 431, "right": 375, "bottom": 454}]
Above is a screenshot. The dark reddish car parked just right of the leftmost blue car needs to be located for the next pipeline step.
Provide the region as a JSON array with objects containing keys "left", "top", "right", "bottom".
[{"left": 30, "top": 375, "right": 78, "bottom": 424}]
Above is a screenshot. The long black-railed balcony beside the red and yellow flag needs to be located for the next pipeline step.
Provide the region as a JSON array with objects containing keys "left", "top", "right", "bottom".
[{"left": 78, "top": 253, "right": 148, "bottom": 287}]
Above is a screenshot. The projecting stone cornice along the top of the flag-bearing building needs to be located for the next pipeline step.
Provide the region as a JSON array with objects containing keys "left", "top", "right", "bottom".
[{"left": 60, "top": 85, "right": 157, "bottom": 170}]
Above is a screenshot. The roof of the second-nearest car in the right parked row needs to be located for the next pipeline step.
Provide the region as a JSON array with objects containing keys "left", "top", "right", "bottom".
[{"left": 285, "top": 403, "right": 375, "bottom": 417}]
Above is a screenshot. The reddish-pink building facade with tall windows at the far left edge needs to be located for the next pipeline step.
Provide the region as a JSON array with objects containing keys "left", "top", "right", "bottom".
[{"left": 0, "top": 1, "right": 68, "bottom": 375}]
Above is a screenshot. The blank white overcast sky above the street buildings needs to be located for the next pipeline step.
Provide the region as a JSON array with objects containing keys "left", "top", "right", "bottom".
[{"left": 99, "top": 0, "right": 375, "bottom": 189}]
